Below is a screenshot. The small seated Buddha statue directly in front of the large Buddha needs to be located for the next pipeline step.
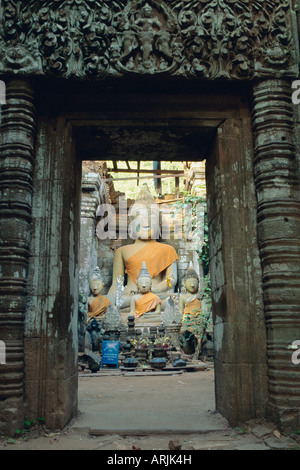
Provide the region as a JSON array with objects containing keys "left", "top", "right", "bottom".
[{"left": 130, "top": 261, "right": 161, "bottom": 318}]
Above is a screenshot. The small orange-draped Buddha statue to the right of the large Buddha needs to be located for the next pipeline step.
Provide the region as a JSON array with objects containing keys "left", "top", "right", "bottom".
[{"left": 179, "top": 267, "right": 202, "bottom": 331}]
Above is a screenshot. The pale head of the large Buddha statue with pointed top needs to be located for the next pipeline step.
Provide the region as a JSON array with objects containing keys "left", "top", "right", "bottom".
[{"left": 129, "top": 184, "right": 160, "bottom": 240}]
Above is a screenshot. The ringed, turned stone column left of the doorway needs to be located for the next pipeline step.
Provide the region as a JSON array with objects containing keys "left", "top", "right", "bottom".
[{"left": 0, "top": 81, "right": 36, "bottom": 435}]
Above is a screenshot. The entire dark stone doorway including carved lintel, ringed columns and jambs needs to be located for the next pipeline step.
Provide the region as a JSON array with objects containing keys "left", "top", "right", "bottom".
[{"left": 0, "top": 0, "right": 300, "bottom": 433}]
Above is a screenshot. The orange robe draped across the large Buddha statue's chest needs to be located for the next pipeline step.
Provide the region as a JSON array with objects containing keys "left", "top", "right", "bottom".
[{"left": 125, "top": 240, "right": 178, "bottom": 283}]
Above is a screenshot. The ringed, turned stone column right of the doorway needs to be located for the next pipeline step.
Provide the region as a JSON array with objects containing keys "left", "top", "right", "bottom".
[{"left": 253, "top": 80, "right": 300, "bottom": 431}]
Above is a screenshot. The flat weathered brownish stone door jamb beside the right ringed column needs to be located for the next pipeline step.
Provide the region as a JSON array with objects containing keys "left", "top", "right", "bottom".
[{"left": 207, "top": 113, "right": 268, "bottom": 426}]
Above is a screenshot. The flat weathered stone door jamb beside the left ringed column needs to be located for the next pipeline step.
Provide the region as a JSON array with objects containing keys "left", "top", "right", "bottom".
[{"left": 25, "top": 114, "right": 81, "bottom": 429}]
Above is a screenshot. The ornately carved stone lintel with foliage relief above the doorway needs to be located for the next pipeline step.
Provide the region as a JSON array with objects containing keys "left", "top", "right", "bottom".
[{"left": 0, "top": 0, "right": 297, "bottom": 79}]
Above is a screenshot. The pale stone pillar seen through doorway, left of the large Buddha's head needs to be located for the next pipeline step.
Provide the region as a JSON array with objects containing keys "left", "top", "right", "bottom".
[{"left": 79, "top": 173, "right": 101, "bottom": 296}]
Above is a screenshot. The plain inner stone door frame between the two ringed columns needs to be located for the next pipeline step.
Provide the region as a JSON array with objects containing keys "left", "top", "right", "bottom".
[{"left": 15, "top": 80, "right": 266, "bottom": 434}]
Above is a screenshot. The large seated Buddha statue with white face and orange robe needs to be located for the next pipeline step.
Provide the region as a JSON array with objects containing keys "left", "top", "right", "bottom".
[{"left": 107, "top": 184, "right": 178, "bottom": 308}]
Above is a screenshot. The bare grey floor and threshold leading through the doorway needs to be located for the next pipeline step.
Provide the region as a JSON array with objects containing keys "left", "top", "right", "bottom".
[{"left": 0, "top": 367, "right": 300, "bottom": 452}]
